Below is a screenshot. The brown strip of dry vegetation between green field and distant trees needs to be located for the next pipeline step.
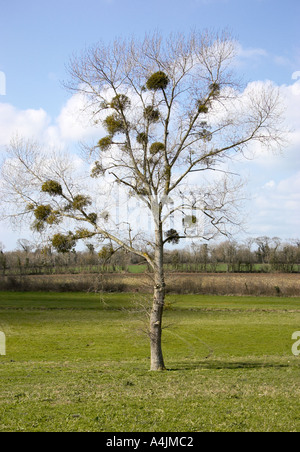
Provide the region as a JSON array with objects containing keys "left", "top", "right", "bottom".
[{"left": 0, "top": 273, "right": 300, "bottom": 297}]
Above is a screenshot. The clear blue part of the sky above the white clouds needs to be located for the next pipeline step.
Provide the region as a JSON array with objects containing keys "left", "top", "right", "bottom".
[{"left": 0, "top": 0, "right": 300, "bottom": 115}]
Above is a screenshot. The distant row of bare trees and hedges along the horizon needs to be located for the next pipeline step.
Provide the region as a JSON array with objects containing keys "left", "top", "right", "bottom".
[{"left": 0, "top": 236, "right": 300, "bottom": 276}]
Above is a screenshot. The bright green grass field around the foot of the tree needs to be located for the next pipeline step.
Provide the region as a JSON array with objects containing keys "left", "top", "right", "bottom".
[{"left": 0, "top": 292, "right": 300, "bottom": 432}]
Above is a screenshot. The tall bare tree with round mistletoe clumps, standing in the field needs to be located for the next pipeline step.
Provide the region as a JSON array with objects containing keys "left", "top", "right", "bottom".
[{"left": 2, "top": 32, "right": 282, "bottom": 370}]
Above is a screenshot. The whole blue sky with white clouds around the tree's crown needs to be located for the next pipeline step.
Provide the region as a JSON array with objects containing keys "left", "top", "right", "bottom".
[{"left": 0, "top": 0, "right": 300, "bottom": 250}]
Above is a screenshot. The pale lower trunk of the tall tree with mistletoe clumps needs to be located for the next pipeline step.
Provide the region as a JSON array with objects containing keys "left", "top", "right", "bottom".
[{"left": 150, "top": 225, "right": 165, "bottom": 371}]
